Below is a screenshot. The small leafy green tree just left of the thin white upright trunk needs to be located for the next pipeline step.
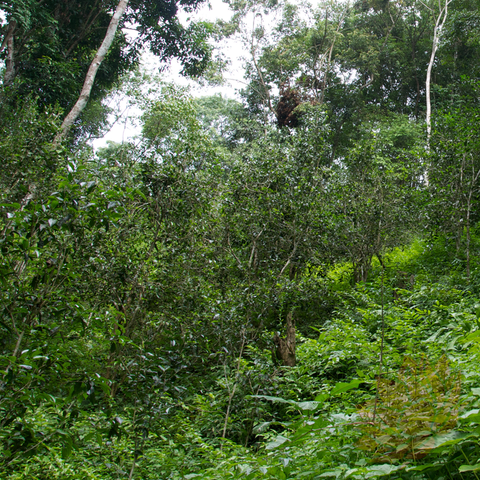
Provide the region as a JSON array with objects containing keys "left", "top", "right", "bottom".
[{"left": 329, "top": 116, "right": 421, "bottom": 283}]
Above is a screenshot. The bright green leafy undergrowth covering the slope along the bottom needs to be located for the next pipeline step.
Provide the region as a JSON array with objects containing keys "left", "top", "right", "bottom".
[{"left": 4, "top": 241, "right": 480, "bottom": 480}]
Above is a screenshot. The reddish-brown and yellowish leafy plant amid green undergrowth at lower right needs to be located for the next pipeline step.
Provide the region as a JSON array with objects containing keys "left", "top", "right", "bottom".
[{"left": 358, "top": 356, "right": 461, "bottom": 462}]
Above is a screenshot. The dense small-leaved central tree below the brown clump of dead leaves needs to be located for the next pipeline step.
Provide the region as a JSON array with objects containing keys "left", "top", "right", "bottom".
[{"left": 219, "top": 105, "right": 331, "bottom": 338}]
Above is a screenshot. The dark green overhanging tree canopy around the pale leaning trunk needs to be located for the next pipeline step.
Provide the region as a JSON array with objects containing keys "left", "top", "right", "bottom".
[{"left": 0, "top": 0, "right": 211, "bottom": 137}]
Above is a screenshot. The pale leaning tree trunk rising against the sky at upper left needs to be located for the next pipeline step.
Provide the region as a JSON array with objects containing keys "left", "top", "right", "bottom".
[{"left": 55, "top": 0, "right": 128, "bottom": 143}]
